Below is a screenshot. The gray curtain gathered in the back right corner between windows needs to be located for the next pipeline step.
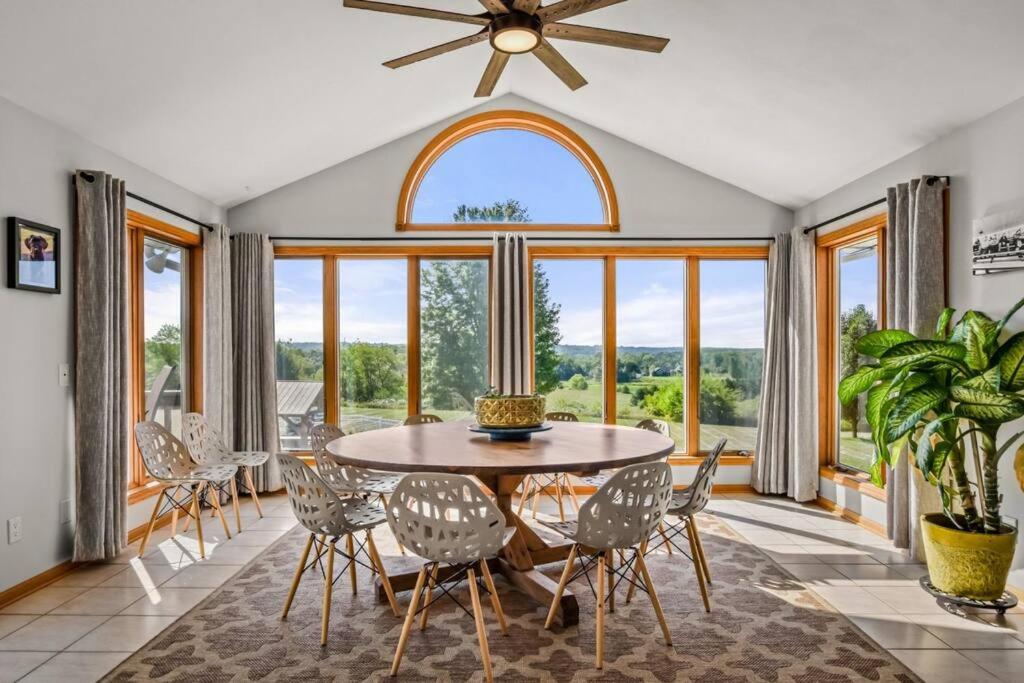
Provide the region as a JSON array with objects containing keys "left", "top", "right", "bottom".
[{"left": 751, "top": 227, "right": 818, "bottom": 502}]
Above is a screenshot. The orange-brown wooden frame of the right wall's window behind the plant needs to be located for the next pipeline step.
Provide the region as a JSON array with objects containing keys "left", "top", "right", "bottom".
[{"left": 815, "top": 213, "right": 888, "bottom": 485}]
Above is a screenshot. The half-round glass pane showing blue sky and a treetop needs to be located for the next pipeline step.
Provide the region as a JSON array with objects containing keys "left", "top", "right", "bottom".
[{"left": 412, "top": 129, "right": 605, "bottom": 223}]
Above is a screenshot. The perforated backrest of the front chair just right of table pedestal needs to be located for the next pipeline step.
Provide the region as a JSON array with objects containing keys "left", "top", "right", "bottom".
[{"left": 577, "top": 461, "right": 672, "bottom": 549}]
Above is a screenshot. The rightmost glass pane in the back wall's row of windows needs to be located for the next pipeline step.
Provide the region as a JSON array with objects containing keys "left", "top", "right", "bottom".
[{"left": 699, "top": 259, "right": 765, "bottom": 452}]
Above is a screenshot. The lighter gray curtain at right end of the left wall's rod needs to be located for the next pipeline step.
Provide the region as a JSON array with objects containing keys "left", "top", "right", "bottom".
[{"left": 203, "top": 225, "right": 234, "bottom": 449}]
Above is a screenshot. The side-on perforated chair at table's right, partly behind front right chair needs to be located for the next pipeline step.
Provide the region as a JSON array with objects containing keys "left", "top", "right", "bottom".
[{"left": 626, "top": 438, "right": 726, "bottom": 612}]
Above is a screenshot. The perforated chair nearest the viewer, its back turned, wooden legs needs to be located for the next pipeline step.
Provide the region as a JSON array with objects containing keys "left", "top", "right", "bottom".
[{"left": 387, "top": 474, "right": 515, "bottom": 681}]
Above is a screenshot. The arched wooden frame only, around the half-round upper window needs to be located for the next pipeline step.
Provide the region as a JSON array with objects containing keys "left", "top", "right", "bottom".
[{"left": 395, "top": 110, "right": 618, "bottom": 232}]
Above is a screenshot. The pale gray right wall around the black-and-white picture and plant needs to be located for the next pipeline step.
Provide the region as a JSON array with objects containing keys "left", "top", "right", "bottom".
[{"left": 797, "top": 94, "right": 1024, "bottom": 586}]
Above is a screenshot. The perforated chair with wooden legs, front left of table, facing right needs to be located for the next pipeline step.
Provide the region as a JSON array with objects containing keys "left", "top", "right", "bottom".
[{"left": 278, "top": 453, "right": 401, "bottom": 646}]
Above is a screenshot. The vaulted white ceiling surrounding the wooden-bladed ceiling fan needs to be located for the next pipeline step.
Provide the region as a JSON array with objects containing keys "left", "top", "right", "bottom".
[{"left": 0, "top": 0, "right": 1024, "bottom": 207}]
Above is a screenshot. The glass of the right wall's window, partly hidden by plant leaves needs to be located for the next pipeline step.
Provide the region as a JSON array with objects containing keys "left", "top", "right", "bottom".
[{"left": 835, "top": 238, "right": 879, "bottom": 471}]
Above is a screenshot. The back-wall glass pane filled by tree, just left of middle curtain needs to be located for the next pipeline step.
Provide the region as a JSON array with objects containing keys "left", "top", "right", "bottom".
[{"left": 420, "top": 259, "right": 489, "bottom": 421}]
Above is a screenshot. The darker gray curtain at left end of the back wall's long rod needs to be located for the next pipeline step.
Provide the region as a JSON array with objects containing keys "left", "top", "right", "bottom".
[{"left": 230, "top": 232, "right": 283, "bottom": 492}]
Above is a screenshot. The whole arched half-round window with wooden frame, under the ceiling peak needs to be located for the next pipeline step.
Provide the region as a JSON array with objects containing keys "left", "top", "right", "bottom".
[{"left": 395, "top": 111, "right": 618, "bottom": 231}]
